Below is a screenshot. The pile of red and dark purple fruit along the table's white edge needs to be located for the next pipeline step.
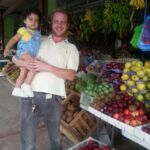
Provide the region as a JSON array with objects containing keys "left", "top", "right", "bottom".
[{"left": 100, "top": 93, "right": 148, "bottom": 126}]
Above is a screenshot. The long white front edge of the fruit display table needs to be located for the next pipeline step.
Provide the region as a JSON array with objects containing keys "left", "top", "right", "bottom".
[{"left": 80, "top": 103, "right": 150, "bottom": 150}]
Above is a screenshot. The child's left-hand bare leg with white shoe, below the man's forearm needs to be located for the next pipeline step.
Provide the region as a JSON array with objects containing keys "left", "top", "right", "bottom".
[{"left": 12, "top": 68, "right": 27, "bottom": 97}]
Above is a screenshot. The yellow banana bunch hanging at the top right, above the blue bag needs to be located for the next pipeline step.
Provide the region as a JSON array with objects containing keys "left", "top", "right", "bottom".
[{"left": 129, "top": 0, "right": 145, "bottom": 10}]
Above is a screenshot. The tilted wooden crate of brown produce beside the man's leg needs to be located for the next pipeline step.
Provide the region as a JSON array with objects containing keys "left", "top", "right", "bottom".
[{"left": 61, "top": 92, "right": 96, "bottom": 143}]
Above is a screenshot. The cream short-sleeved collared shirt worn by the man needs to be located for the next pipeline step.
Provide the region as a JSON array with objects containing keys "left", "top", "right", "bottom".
[{"left": 31, "top": 35, "right": 79, "bottom": 97}]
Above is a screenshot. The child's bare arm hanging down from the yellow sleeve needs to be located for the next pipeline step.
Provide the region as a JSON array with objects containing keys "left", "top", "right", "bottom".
[{"left": 4, "top": 33, "right": 21, "bottom": 57}]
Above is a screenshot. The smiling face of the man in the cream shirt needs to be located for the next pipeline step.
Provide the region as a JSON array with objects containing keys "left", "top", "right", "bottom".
[{"left": 52, "top": 12, "right": 68, "bottom": 37}]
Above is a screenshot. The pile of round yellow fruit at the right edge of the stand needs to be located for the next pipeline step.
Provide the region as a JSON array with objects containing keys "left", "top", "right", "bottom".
[{"left": 120, "top": 60, "right": 150, "bottom": 110}]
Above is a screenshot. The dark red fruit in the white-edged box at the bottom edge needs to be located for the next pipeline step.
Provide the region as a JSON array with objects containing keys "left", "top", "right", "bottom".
[{"left": 77, "top": 140, "right": 112, "bottom": 150}]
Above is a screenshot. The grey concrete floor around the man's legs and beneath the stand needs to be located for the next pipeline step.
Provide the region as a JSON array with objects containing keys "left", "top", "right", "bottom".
[{"left": 0, "top": 77, "right": 146, "bottom": 150}]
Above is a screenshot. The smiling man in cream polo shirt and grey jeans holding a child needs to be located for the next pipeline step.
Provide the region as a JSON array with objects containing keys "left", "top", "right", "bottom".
[{"left": 13, "top": 10, "right": 79, "bottom": 150}]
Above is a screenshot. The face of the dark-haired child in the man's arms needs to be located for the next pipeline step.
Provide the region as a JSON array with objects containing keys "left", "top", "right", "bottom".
[{"left": 24, "top": 13, "right": 39, "bottom": 30}]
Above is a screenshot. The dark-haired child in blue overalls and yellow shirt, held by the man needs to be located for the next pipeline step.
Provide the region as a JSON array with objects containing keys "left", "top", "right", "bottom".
[{"left": 4, "top": 8, "right": 41, "bottom": 97}]
